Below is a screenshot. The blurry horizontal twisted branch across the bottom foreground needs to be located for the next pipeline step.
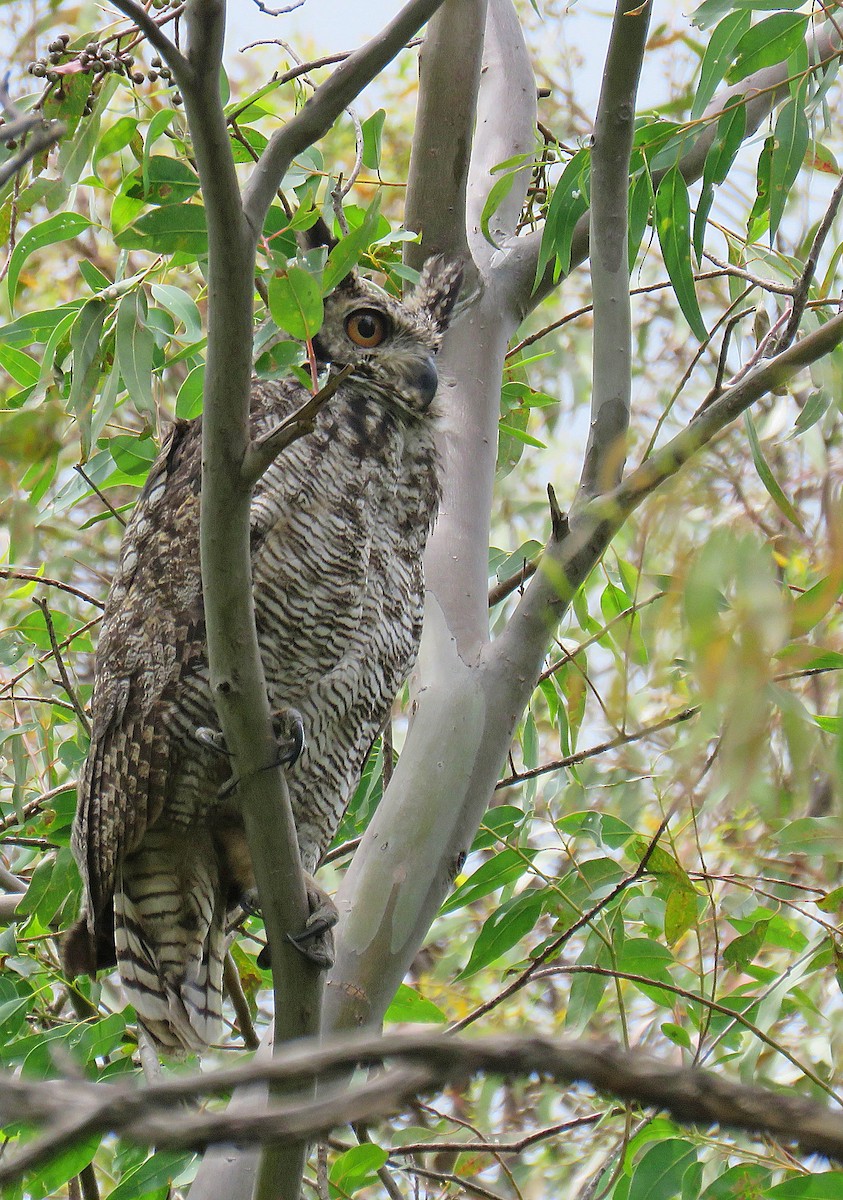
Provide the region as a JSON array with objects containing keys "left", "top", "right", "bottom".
[{"left": 8, "top": 1027, "right": 843, "bottom": 1184}]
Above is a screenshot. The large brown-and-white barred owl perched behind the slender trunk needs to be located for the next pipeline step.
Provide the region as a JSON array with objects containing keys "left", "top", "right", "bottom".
[{"left": 64, "top": 259, "right": 461, "bottom": 1052}]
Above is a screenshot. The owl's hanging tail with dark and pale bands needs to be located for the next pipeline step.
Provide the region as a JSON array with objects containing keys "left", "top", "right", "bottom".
[{"left": 114, "top": 828, "right": 226, "bottom": 1055}]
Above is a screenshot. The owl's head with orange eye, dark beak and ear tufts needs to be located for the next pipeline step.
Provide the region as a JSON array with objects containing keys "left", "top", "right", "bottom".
[{"left": 313, "top": 258, "right": 462, "bottom": 416}]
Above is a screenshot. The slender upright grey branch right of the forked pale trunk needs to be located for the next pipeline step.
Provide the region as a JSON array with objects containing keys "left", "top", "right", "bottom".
[{"left": 578, "top": 0, "right": 652, "bottom": 500}]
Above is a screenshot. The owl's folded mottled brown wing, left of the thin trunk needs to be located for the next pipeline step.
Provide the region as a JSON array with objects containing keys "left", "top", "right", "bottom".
[{"left": 73, "top": 422, "right": 204, "bottom": 928}]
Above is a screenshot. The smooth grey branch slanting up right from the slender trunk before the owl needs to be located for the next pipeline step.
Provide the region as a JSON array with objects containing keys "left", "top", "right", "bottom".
[{"left": 244, "top": 0, "right": 442, "bottom": 238}]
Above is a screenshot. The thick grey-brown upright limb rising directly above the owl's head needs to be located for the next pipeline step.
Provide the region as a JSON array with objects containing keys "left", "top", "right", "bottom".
[{"left": 405, "top": 0, "right": 486, "bottom": 272}]
